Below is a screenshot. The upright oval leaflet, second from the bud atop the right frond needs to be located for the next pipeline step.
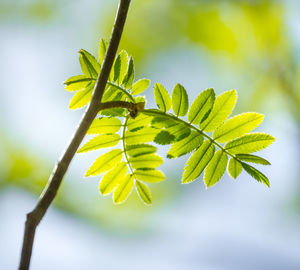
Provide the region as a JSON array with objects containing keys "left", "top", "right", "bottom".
[{"left": 172, "top": 83, "right": 189, "bottom": 116}]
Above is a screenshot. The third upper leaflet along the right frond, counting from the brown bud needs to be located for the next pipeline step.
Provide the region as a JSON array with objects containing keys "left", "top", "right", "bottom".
[{"left": 188, "top": 88, "right": 215, "bottom": 125}]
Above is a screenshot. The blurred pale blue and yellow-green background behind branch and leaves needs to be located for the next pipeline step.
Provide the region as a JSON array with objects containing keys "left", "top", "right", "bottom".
[{"left": 0, "top": 0, "right": 300, "bottom": 270}]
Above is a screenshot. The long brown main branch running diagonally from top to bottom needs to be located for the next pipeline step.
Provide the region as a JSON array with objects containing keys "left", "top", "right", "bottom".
[{"left": 19, "top": 0, "right": 130, "bottom": 270}]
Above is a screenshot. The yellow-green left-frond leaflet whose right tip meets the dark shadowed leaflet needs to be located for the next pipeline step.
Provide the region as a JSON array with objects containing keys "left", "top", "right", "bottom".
[{"left": 125, "top": 127, "right": 159, "bottom": 144}]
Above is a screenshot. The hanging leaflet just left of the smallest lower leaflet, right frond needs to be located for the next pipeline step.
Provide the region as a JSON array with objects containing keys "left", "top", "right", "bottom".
[{"left": 203, "top": 149, "right": 228, "bottom": 187}]
